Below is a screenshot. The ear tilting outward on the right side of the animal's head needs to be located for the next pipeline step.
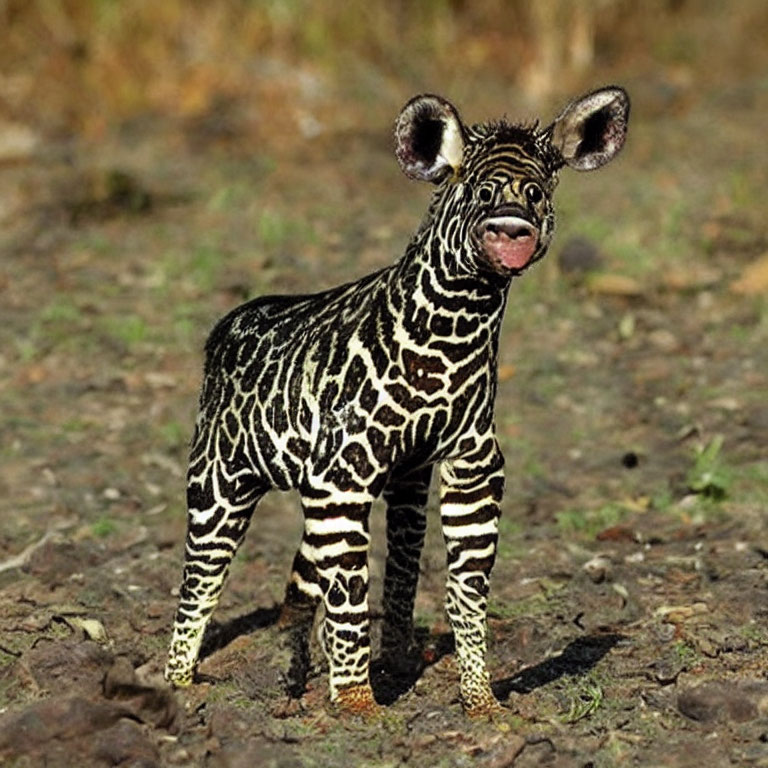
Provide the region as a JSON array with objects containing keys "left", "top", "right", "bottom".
[{"left": 547, "top": 86, "right": 629, "bottom": 171}]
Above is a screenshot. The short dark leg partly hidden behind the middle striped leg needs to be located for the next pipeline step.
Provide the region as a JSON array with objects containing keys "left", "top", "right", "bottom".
[{"left": 279, "top": 530, "right": 323, "bottom": 698}]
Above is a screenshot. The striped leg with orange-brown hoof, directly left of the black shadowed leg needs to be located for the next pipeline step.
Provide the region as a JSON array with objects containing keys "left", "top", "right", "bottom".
[{"left": 300, "top": 497, "right": 378, "bottom": 715}]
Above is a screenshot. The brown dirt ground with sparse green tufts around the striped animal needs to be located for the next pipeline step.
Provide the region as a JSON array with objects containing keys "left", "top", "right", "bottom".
[{"left": 0, "top": 21, "right": 768, "bottom": 768}]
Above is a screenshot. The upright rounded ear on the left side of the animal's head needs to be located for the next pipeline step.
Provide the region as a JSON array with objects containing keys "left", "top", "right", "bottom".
[{"left": 395, "top": 94, "right": 464, "bottom": 184}]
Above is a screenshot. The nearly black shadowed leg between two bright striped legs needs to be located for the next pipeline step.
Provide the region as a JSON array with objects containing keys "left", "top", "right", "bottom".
[{"left": 381, "top": 466, "right": 432, "bottom": 669}]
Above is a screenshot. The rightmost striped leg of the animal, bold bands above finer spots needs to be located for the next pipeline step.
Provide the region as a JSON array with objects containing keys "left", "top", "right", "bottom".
[{"left": 440, "top": 437, "right": 504, "bottom": 715}]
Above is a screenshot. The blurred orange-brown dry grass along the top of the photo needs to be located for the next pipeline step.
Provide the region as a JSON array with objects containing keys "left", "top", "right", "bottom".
[{"left": 0, "top": 0, "right": 768, "bottom": 138}]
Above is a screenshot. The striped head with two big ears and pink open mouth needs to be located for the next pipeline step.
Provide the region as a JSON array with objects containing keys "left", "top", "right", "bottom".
[{"left": 395, "top": 86, "right": 629, "bottom": 278}]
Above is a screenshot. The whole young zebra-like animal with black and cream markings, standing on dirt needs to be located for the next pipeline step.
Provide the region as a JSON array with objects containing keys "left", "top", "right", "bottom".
[{"left": 165, "top": 86, "right": 629, "bottom": 716}]
